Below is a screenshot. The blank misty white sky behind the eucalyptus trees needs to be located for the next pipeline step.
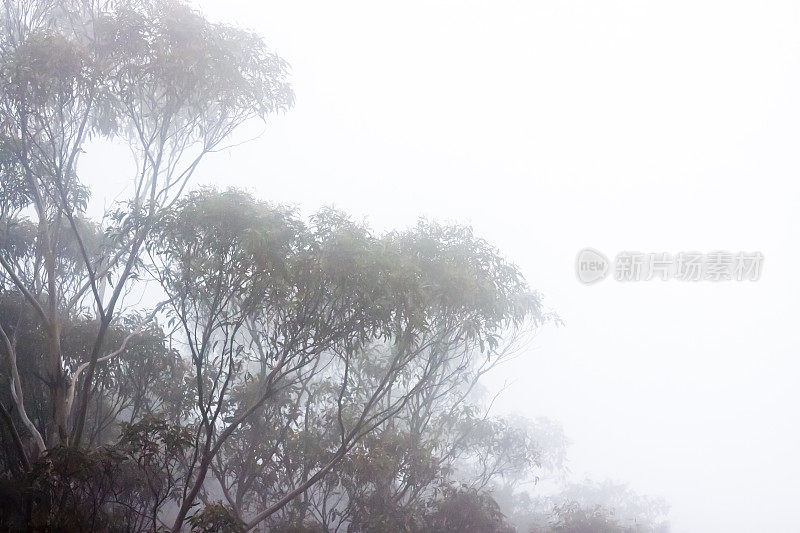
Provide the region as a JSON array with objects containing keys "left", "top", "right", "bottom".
[{"left": 84, "top": 0, "right": 800, "bottom": 533}]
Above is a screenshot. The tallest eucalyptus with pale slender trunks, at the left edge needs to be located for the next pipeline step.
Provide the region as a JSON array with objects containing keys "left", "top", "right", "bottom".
[{"left": 0, "top": 0, "right": 293, "bottom": 453}]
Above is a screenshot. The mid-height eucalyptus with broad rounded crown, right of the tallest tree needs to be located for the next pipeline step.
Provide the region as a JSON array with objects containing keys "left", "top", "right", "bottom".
[{"left": 149, "top": 190, "right": 545, "bottom": 530}]
